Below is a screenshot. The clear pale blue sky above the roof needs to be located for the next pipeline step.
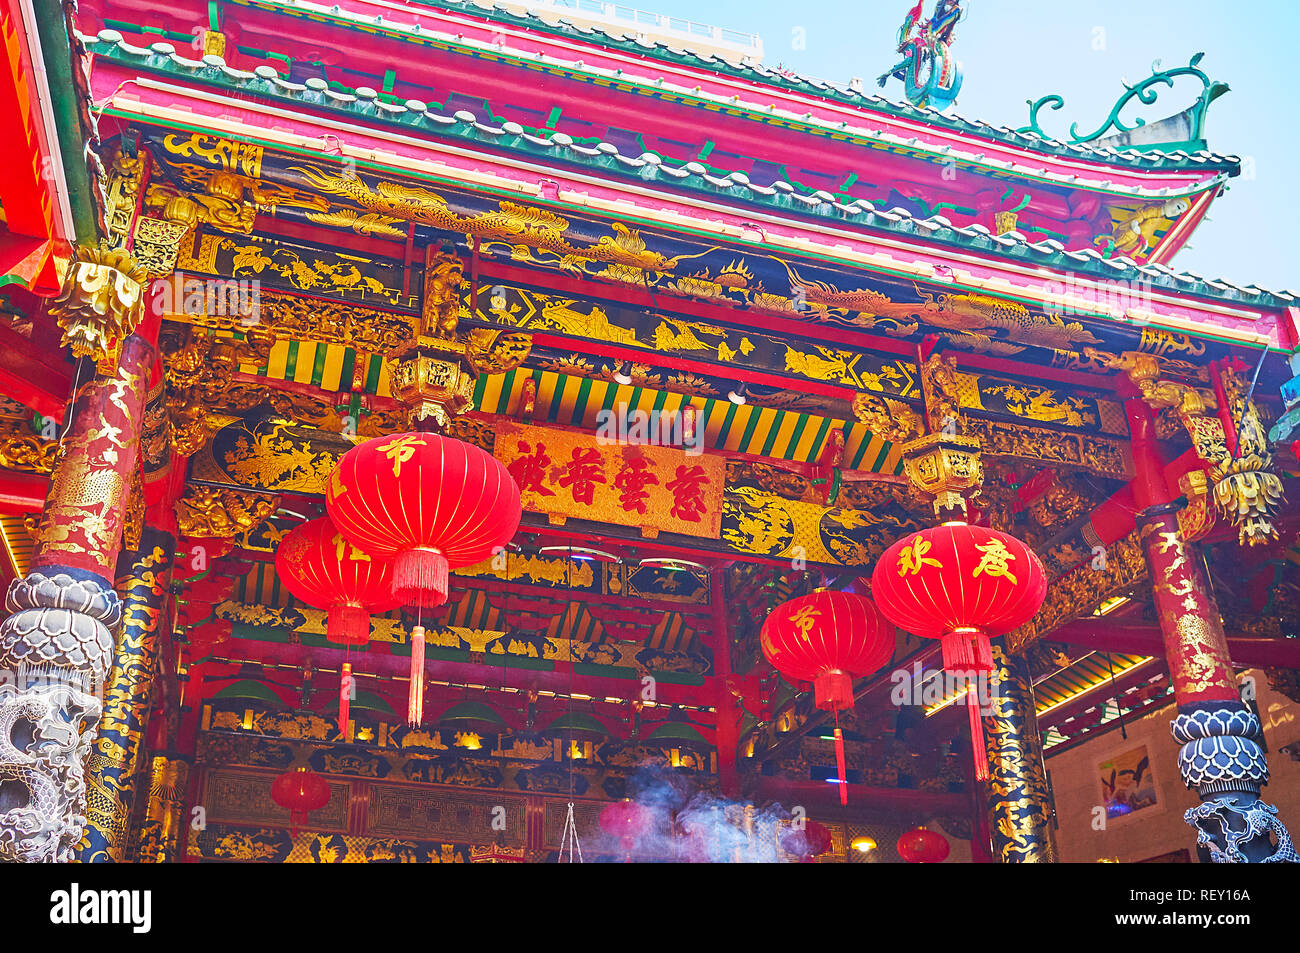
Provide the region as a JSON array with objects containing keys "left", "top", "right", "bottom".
[{"left": 624, "top": 0, "right": 1300, "bottom": 290}]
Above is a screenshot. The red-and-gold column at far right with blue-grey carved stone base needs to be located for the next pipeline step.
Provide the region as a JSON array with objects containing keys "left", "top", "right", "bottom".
[{"left": 1126, "top": 400, "right": 1300, "bottom": 863}]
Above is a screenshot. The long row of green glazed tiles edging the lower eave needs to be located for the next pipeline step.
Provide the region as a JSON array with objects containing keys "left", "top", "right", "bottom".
[{"left": 86, "top": 30, "right": 1300, "bottom": 307}]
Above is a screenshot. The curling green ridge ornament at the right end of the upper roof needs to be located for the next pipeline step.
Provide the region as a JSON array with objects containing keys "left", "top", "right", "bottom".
[{"left": 1015, "top": 53, "right": 1230, "bottom": 151}]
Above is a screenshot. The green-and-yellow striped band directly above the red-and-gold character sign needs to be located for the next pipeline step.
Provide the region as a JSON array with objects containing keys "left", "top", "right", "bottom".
[{"left": 475, "top": 368, "right": 902, "bottom": 473}]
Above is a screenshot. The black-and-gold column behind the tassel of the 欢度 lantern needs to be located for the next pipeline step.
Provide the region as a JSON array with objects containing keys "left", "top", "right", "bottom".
[{"left": 984, "top": 642, "right": 1057, "bottom": 863}]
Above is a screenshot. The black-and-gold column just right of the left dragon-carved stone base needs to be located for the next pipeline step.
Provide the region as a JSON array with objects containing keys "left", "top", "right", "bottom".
[{"left": 77, "top": 529, "right": 176, "bottom": 863}]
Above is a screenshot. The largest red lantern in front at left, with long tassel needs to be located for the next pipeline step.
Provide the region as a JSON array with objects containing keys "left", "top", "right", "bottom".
[{"left": 325, "top": 433, "right": 523, "bottom": 725}]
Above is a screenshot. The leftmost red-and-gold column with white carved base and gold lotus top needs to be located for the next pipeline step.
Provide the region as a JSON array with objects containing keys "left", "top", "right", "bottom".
[{"left": 0, "top": 251, "right": 155, "bottom": 862}]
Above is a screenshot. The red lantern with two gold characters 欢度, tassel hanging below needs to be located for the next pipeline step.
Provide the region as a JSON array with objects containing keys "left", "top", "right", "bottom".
[{"left": 871, "top": 523, "right": 1048, "bottom": 781}]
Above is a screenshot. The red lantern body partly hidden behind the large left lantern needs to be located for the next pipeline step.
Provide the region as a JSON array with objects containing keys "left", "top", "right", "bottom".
[{"left": 276, "top": 516, "right": 402, "bottom": 645}]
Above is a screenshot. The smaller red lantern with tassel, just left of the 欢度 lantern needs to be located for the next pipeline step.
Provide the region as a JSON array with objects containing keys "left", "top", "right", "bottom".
[{"left": 759, "top": 589, "right": 894, "bottom": 805}]
